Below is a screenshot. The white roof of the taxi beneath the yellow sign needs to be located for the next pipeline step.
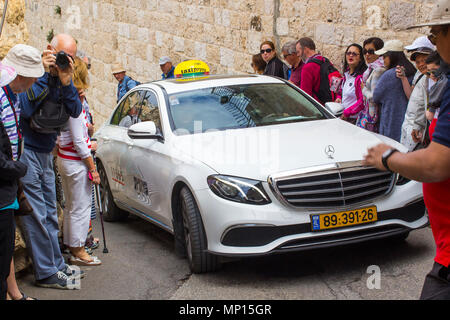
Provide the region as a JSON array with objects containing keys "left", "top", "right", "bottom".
[{"left": 144, "top": 75, "right": 283, "bottom": 94}]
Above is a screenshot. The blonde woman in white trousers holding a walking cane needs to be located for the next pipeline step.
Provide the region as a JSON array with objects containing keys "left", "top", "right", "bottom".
[{"left": 58, "top": 57, "right": 101, "bottom": 266}]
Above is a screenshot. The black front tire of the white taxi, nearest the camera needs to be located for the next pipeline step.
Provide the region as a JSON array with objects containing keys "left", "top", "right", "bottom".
[{"left": 180, "top": 187, "right": 220, "bottom": 273}]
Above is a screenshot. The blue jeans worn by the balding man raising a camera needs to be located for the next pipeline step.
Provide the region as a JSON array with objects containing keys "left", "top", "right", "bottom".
[{"left": 20, "top": 148, "right": 65, "bottom": 280}]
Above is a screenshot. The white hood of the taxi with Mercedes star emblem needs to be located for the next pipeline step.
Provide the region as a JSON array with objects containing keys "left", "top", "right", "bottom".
[{"left": 172, "top": 119, "right": 406, "bottom": 181}]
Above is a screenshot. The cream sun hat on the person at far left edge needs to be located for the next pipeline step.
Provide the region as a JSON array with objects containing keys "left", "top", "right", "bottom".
[{"left": 2, "top": 44, "right": 45, "bottom": 78}]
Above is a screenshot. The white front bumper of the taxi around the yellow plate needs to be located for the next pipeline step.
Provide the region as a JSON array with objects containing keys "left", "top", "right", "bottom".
[{"left": 196, "top": 182, "right": 429, "bottom": 256}]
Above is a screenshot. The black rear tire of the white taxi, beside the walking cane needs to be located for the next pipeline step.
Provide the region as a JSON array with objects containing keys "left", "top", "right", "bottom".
[{"left": 97, "top": 163, "right": 128, "bottom": 222}]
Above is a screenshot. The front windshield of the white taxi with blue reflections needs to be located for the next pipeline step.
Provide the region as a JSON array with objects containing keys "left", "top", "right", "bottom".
[{"left": 169, "top": 84, "right": 327, "bottom": 134}]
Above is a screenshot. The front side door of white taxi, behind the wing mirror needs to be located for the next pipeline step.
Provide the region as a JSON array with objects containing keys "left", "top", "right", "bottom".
[{"left": 123, "top": 89, "right": 171, "bottom": 228}]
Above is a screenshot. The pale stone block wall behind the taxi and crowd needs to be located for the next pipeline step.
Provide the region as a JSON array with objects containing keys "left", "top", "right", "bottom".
[{"left": 25, "top": 0, "right": 432, "bottom": 125}]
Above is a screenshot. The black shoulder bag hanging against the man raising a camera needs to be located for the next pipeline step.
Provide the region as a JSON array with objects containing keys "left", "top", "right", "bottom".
[{"left": 28, "top": 85, "right": 70, "bottom": 134}]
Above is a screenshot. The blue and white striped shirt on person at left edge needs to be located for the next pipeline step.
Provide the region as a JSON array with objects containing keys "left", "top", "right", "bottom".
[{"left": 0, "top": 86, "right": 20, "bottom": 161}]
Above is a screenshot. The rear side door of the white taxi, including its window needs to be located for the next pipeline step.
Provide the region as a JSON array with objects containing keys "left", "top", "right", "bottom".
[{"left": 102, "top": 91, "right": 142, "bottom": 203}]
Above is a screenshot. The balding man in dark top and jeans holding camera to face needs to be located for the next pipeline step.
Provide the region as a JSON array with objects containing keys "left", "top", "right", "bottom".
[{"left": 19, "top": 34, "right": 82, "bottom": 289}]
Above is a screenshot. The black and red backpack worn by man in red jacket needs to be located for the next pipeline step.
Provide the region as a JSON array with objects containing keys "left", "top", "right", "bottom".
[{"left": 308, "top": 57, "right": 342, "bottom": 104}]
